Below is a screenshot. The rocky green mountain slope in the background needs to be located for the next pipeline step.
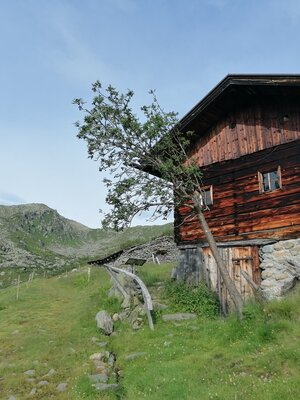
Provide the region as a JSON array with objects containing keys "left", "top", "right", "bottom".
[{"left": 0, "top": 204, "right": 172, "bottom": 271}]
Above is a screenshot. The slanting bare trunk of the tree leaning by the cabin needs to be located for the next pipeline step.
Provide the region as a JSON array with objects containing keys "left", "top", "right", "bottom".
[{"left": 192, "top": 193, "right": 243, "bottom": 320}]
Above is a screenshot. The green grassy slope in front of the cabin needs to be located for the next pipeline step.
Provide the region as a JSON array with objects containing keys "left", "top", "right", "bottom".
[{"left": 0, "top": 265, "right": 300, "bottom": 400}]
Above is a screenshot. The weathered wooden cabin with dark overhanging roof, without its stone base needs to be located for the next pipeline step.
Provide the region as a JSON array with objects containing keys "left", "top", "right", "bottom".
[{"left": 175, "top": 75, "right": 300, "bottom": 309}]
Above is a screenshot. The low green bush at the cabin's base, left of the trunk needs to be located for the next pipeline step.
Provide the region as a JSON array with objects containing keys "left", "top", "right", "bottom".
[{"left": 166, "top": 281, "right": 219, "bottom": 317}]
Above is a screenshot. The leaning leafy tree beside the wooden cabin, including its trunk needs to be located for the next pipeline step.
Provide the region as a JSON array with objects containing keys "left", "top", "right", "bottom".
[{"left": 74, "top": 81, "right": 243, "bottom": 318}]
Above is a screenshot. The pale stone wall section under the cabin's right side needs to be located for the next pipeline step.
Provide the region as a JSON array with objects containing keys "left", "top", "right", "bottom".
[{"left": 260, "top": 239, "right": 300, "bottom": 299}]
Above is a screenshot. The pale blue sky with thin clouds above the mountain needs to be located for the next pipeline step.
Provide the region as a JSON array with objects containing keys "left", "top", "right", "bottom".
[{"left": 0, "top": 0, "right": 300, "bottom": 228}]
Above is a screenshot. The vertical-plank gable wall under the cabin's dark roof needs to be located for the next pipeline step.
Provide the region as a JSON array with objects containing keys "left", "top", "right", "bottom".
[{"left": 192, "top": 103, "right": 300, "bottom": 166}]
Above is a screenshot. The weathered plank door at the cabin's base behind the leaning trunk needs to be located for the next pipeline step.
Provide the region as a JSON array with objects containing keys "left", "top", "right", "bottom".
[{"left": 203, "top": 246, "right": 260, "bottom": 314}]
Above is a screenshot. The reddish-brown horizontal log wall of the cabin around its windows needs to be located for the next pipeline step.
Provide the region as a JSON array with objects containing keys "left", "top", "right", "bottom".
[{"left": 175, "top": 140, "right": 300, "bottom": 244}]
